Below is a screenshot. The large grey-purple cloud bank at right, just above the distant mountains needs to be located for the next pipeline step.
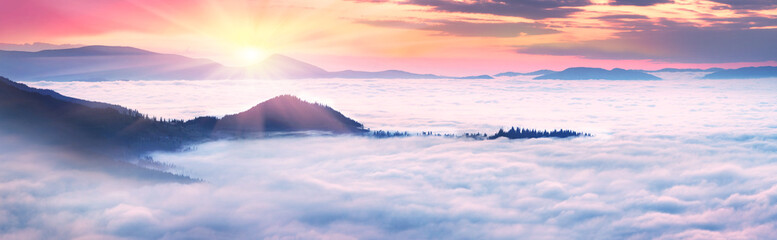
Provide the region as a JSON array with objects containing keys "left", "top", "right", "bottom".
[{"left": 517, "top": 28, "right": 777, "bottom": 63}]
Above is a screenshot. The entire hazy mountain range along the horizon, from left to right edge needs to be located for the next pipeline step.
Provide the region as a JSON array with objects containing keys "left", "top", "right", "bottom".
[{"left": 0, "top": 46, "right": 777, "bottom": 81}]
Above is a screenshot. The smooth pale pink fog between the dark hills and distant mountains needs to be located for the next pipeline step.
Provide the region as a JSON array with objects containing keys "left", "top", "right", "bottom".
[{"left": 28, "top": 73, "right": 777, "bottom": 134}]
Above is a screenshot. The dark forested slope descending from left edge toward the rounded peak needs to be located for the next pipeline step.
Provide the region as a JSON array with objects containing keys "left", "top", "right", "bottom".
[{"left": 0, "top": 78, "right": 208, "bottom": 155}]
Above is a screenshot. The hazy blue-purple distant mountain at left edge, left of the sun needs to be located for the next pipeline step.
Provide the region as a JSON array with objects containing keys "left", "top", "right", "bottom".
[{"left": 0, "top": 46, "right": 227, "bottom": 81}]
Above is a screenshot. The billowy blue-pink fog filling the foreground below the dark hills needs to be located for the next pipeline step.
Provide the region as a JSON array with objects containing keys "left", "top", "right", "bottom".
[{"left": 0, "top": 131, "right": 777, "bottom": 239}]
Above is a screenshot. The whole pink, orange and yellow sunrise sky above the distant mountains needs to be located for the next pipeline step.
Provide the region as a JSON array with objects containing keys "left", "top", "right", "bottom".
[{"left": 0, "top": 0, "right": 777, "bottom": 74}]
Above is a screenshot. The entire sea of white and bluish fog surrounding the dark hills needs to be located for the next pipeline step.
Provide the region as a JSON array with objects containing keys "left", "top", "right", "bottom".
[{"left": 0, "top": 73, "right": 777, "bottom": 239}]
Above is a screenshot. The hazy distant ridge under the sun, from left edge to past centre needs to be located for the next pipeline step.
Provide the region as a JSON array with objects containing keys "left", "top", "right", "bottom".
[{"left": 0, "top": 46, "right": 490, "bottom": 81}]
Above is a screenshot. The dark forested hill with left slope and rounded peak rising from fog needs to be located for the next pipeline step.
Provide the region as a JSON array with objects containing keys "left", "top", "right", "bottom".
[{"left": 0, "top": 77, "right": 364, "bottom": 156}]
